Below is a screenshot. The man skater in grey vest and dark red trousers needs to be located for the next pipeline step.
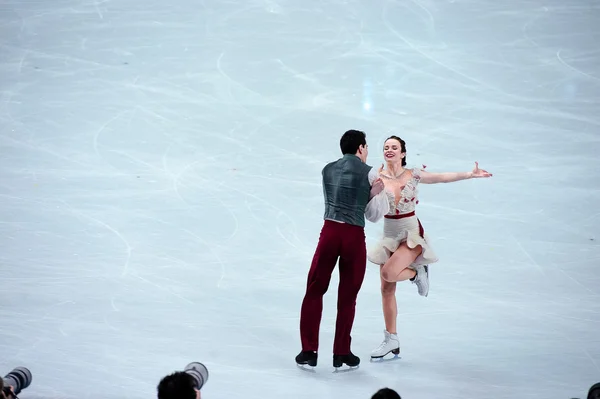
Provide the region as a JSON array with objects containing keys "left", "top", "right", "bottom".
[{"left": 296, "top": 130, "right": 387, "bottom": 368}]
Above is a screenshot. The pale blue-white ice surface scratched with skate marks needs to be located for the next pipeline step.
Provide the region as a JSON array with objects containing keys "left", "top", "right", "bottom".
[{"left": 0, "top": 0, "right": 600, "bottom": 399}]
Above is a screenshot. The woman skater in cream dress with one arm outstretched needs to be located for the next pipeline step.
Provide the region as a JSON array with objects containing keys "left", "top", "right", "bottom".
[{"left": 366, "top": 136, "right": 492, "bottom": 358}]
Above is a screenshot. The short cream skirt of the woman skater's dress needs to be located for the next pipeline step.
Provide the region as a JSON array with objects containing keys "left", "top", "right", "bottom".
[{"left": 367, "top": 216, "right": 438, "bottom": 268}]
